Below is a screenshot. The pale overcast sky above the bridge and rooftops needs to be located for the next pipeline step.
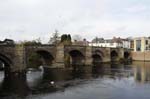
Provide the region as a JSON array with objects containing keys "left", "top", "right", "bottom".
[{"left": 0, "top": 0, "right": 150, "bottom": 43}]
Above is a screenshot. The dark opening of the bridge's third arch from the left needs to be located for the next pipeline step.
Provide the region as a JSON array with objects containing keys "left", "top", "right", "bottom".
[{"left": 69, "top": 50, "right": 85, "bottom": 65}]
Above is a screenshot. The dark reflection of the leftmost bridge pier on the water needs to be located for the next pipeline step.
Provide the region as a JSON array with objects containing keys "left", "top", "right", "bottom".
[{"left": 0, "top": 73, "right": 29, "bottom": 98}]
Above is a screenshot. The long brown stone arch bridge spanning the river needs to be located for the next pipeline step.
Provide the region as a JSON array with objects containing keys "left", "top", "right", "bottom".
[{"left": 0, "top": 45, "right": 129, "bottom": 72}]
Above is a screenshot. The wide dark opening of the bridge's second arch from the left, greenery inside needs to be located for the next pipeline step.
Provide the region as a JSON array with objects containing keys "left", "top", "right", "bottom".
[{"left": 28, "top": 50, "right": 54, "bottom": 67}]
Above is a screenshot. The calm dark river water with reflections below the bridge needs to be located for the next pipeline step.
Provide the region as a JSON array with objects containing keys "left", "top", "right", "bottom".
[{"left": 0, "top": 62, "right": 150, "bottom": 99}]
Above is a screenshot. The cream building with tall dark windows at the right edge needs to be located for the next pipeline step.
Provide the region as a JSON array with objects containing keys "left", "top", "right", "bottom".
[{"left": 134, "top": 37, "right": 150, "bottom": 52}]
